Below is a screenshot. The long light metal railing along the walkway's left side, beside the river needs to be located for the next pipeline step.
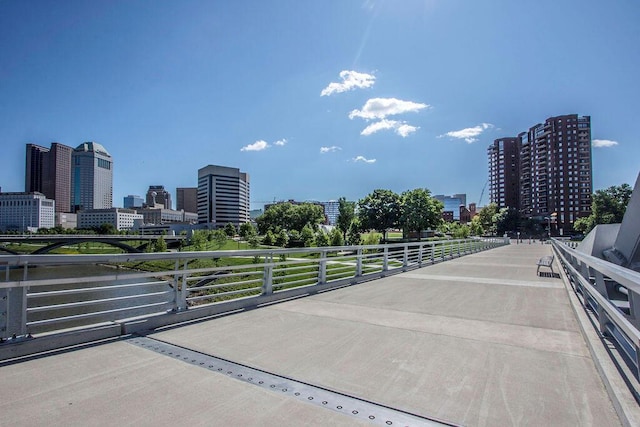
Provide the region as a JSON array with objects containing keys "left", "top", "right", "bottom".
[{"left": 0, "top": 238, "right": 508, "bottom": 342}]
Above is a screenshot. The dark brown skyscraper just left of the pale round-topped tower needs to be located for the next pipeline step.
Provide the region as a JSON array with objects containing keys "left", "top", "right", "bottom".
[{"left": 25, "top": 142, "right": 73, "bottom": 212}]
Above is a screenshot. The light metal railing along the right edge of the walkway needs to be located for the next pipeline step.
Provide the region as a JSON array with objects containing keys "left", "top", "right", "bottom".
[{"left": 552, "top": 239, "right": 640, "bottom": 379}]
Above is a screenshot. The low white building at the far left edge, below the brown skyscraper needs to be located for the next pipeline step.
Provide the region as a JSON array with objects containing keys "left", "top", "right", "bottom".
[{"left": 0, "top": 191, "right": 56, "bottom": 233}]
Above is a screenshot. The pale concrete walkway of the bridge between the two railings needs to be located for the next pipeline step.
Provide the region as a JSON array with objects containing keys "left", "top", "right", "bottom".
[{"left": 0, "top": 244, "right": 620, "bottom": 426}]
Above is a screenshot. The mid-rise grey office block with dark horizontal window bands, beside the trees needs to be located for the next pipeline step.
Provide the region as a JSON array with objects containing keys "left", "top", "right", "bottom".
[{"left": 198, "top": 165, "right": 250, "bottom": 228}]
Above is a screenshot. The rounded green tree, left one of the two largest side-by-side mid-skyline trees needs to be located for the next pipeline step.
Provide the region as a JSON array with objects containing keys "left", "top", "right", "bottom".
[{"left": 358, "top": 189, "right": 402, "bottom": 241}]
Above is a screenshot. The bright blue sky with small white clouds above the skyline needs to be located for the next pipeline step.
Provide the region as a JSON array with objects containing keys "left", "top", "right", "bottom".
[{"left": 0, "top": 0, "right": 640, "bottom": 208}]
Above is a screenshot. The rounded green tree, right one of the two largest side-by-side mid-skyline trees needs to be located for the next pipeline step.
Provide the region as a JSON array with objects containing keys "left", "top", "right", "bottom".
[{"left": 400, "top": 188, "right": 444, "bottom": 240}]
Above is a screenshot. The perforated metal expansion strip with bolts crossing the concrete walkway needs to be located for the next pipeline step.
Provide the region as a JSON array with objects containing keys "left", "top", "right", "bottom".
[{"left": 127, "top": 337, "right": 455, "bottom": 426}]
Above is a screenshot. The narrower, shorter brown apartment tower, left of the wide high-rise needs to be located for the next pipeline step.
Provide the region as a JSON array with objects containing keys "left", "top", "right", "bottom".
[{"left": 487, "top": 138, "right": 520, "bottom": 209}]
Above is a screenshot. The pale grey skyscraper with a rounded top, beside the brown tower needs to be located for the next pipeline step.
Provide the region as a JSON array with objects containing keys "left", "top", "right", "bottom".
[{"left": 71, "top": 142, "right": 113, "bottom": 212}]
